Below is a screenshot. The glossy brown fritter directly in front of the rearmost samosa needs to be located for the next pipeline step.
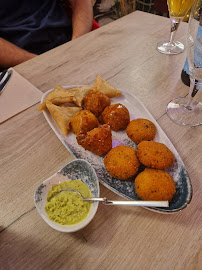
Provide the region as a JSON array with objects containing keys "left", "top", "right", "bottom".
[{"left": 83, "top": 90, "right": 111, "bottom": 117}]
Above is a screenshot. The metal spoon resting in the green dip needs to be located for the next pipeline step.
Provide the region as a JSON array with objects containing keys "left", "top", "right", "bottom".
[{"left": 58, "top": 189, "right": 169, "bottom": 207}]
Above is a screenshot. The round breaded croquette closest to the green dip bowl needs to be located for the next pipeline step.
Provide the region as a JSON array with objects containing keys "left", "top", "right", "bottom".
[{"left": 104, "top": 145, "right": 140, "bottom": 180}]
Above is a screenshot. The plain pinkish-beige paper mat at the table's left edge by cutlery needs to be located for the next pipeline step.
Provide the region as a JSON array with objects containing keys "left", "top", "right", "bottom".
[{"left": 0, "top": 68, "right": 43, "bottom": 123}]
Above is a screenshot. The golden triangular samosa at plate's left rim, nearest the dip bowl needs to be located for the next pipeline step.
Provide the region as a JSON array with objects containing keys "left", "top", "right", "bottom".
[{"left": 46, "top": 101, "right": 82, "bottom": 135}]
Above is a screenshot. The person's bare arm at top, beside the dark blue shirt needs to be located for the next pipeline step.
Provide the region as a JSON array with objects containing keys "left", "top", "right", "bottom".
[{"left": 72, "top": 0, "right": 93, "bottom": 39}]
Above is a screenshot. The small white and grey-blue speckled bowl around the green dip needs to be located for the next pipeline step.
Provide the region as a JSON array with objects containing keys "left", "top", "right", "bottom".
[{"left": 34, "top": 159, "right": 100, "bottom": 232}]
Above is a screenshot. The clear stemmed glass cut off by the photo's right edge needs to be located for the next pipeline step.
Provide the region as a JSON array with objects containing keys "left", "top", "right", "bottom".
[{"left": 167, "top": 0, "right": 202, "bottom": 126}]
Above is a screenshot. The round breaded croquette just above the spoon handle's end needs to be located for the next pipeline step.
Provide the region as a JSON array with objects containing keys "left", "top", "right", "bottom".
[{"left": 135, "top": 169, "right": 176, "bottom": 201}]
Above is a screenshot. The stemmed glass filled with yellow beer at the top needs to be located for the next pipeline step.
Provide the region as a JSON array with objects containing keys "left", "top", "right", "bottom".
[{"left": 157, "top": 0, "right": 194, "bottom": 54}]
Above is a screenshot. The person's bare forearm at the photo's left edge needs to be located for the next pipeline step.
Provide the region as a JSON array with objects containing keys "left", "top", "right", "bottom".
[{"left": 0, "top": 38, "right": 36, "bottom": 68}]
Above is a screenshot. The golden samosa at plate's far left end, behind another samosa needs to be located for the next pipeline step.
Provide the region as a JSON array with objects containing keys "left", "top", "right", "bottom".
[{"left": 38, "top": 85, "right": 74, "bottom": 111}]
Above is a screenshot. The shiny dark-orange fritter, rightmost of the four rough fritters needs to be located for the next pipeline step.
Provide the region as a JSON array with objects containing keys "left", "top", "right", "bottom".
[{"left": 99, "top": 103, "right": 130, "bottom": 131}]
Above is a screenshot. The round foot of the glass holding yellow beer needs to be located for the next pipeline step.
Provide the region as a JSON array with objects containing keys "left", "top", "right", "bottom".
[{"left": 157, "top": 41, "right": 184, "bottom": 54}]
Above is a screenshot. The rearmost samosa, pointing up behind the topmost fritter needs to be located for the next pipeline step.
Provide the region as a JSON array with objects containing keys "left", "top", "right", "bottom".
[{"left": 93, "top": 75, "right": 121, "bottom": 98}]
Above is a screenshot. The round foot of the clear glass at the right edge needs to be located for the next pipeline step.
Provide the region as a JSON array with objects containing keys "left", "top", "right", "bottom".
[{"left": 166, "top": 98, "right": 202, "bottom": 127}]
